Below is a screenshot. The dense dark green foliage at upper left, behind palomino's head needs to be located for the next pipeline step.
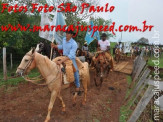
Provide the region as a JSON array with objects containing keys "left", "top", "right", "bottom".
[{"left": 0, "top": 2, "right": 40, "bottom": 58}]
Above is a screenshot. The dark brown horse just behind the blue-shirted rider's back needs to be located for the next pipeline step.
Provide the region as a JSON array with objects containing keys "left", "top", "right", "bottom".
[{"left": 76, "top": 48, "right": 94, "bottom": 64}]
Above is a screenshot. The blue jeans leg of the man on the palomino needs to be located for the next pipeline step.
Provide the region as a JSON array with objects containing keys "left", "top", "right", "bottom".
[{"left": 72, "top": 59, "right": 80, "bottom": 88}]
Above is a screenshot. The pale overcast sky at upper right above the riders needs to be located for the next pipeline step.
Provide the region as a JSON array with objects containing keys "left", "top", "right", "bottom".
[{"left": 96, "top": 0, "right": 163, "bottom": 44}]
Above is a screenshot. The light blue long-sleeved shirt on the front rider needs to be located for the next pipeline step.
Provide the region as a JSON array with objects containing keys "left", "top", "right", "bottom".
[{"left": 58, "top": 38, "right": 78, "bottom": 60}]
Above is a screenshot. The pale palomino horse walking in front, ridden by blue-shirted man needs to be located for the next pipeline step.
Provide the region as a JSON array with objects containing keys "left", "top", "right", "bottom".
[{"left": 16, "top": 49, "right": 90, "bottom": 122}]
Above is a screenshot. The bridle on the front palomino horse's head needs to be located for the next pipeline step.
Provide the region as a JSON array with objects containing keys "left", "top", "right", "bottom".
[{"left": 17, "top": 53, "right": 35, "bottom": 76}]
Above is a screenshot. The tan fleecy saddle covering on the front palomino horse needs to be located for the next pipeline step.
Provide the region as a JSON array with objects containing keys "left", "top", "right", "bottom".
[{"left": 52, "top": 56, "right": 84, "bottom": 84}]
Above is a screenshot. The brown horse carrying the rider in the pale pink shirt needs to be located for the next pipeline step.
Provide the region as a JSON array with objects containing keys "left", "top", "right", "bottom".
[{"left": 91, "top": 51, "right": 114, "bottom": 86}]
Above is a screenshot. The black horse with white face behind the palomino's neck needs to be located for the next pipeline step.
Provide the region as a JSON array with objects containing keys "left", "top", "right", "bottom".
[{"left": 36, "top": 41, "right": 61, "bottom": 59}]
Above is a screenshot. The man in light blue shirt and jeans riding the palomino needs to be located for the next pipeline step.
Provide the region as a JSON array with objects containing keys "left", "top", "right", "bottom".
[{"left": 51, "top": 30, "right": 81, "bottom": 95}]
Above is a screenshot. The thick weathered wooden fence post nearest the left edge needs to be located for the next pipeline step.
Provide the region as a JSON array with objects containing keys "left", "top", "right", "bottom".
[{"left": 3, "top": 47, "right": 7, "bottom": 81}]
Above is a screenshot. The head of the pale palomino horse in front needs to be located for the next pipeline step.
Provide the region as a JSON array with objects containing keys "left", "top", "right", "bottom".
[{"left": 16, "top": 48, "right": 36, "bottom": 76}]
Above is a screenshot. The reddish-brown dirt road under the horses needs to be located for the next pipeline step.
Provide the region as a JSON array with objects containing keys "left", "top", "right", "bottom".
[{"left": 0, "top": 67, "right": 127, "bottom": 122}]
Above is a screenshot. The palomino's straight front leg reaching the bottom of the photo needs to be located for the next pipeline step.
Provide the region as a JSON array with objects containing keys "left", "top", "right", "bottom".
[{"left": 45, "top": 90, "right": 57, "bottom": 122}]
